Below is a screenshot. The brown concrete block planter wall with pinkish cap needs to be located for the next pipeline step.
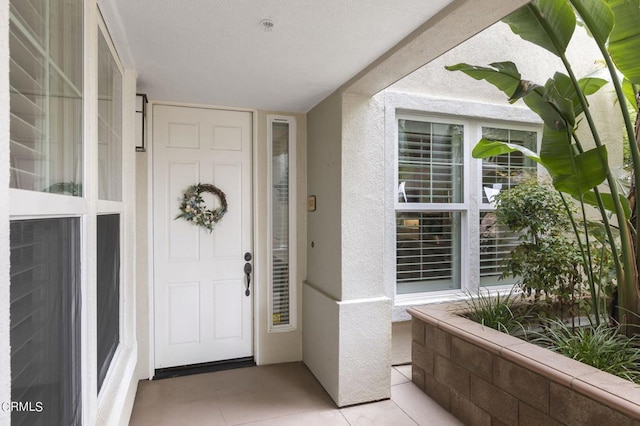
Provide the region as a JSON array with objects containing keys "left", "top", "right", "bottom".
[{"left": 408, "top": 304, "right": 640, "bottom": 426}]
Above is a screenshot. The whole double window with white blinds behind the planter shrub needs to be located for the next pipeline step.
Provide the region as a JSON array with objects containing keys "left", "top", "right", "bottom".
[{"left": 394, "top": 113, "right": 538, "bottom": 296}]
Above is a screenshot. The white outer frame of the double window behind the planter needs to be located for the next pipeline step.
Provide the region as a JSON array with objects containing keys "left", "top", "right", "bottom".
[{"left": 384, "top": 90, "right": 544, "bottom": 322}]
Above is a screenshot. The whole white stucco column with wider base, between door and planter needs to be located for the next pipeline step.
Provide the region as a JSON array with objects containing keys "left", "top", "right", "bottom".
[{"left": 303, "top": 90, "right": 391, "bottom": 406}]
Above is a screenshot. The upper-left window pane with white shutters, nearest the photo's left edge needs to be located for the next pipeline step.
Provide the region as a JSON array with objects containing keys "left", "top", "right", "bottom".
[{"left": 9, "top": 0, "right": 83, "bottom": 196}]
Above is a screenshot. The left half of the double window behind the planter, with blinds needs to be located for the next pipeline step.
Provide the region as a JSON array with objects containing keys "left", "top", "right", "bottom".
[{"left": 396, "top": 119, "right": 464, "bottom": 294}]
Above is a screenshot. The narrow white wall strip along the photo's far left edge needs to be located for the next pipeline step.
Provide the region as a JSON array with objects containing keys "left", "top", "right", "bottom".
[{"left": 0, "top": 0, "right": 11, "bottom": 425}]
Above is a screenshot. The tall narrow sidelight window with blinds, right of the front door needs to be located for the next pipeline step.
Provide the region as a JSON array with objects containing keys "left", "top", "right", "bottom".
[{"left": 268, "top": 116, "right": 296, "bottom": 332}]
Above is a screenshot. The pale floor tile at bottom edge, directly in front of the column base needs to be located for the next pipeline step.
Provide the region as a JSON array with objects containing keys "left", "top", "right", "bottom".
[{"left": 340, "top": 400, "right": 417, "bottom": 426}]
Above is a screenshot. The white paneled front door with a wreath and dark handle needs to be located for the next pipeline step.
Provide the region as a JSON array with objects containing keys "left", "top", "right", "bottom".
[{"left": 152, "top": 105, "right": 254, "bottom": 368}]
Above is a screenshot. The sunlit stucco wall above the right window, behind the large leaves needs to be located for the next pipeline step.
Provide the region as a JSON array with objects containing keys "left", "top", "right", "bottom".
[{"left": 389, "top": 22, "right": 622, "bottom": 164}]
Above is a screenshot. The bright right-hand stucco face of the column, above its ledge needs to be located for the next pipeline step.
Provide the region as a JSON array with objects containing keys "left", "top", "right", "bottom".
[{"left": 341, "top": 95, "right": 387, "bottom": 300}]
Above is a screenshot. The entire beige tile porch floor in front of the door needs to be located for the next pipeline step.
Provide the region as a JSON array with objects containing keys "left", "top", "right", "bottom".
[{"left": 130, "top": 363, "right": 462, "bottom": 426}]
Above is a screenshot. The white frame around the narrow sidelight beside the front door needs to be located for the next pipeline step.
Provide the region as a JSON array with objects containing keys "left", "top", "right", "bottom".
[{"left": 267, "top": 115, "right": 298, "bottom": 333}]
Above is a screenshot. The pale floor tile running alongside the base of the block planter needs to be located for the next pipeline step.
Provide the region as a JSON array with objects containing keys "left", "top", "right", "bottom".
[{"left": 391, "top": 382, "right": 463, "bottom": 426}]
